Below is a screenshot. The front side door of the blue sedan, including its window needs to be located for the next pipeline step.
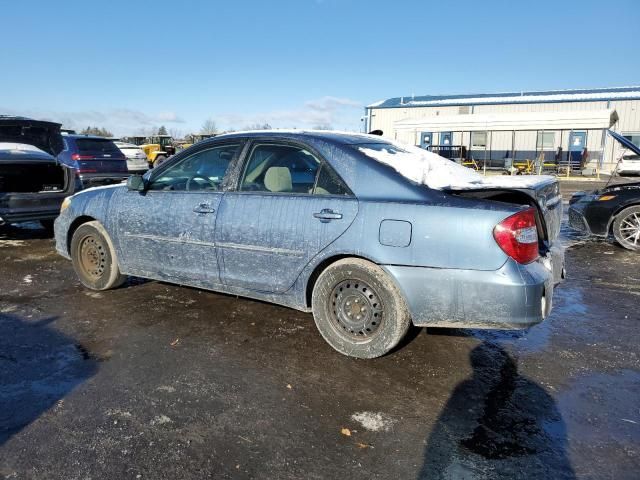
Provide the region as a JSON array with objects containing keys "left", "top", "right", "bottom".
[{"left": 116, "top": 143, "right": 240, "bottom": 285}]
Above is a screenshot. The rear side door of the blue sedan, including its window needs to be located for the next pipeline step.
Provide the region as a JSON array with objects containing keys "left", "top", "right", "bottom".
[{"left": 216, "top": 141, "right": 358, "bottom": 292}]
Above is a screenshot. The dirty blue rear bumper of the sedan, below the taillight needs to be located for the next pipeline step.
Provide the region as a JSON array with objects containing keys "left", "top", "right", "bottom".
[{"left": 383, "top": 247, "right": 564, "bottom": 329}]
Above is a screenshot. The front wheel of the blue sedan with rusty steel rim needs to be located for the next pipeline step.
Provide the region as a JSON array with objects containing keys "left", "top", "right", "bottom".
[{"left": 71, "top": 221, "right": 127, "bottom": 290}]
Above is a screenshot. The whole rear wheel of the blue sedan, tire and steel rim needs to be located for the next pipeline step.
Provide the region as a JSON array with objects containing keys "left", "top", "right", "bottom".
[{"left": 311, "top": 258, "right": 411, "bottom": 358}]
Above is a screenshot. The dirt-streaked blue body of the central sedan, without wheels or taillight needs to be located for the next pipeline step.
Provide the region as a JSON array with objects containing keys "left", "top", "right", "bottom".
[{"left": 55, "top": 131, "right": 564, "bottom": 356}]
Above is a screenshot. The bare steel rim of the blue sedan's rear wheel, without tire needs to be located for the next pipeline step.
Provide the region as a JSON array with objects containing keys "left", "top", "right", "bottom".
[{"left": 330, "top": 280, "right": 384, "bottom": 340}]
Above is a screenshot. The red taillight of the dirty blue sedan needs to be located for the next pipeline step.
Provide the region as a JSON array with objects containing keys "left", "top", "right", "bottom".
[{"left": 493, "top": 208, "right": 539, "bottom": 264}]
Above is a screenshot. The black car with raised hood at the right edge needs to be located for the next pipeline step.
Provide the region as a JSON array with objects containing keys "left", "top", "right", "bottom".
[{"left": 569, "top": 130, "right": 640, "bottom": 251}]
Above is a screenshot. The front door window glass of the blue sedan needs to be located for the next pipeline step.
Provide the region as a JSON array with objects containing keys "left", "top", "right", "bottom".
[{"left": 148, "top": 144, "right": 240, "bottom": 192}]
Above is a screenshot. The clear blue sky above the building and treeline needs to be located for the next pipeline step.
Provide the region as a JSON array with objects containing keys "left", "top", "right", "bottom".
[{"left": 0, "top": 0, "right": 640, "bottom": 135}]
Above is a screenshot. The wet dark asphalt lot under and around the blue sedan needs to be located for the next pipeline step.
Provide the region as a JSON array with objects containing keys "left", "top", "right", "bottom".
[{"left": 0, "top": 185, "right": 640, "bottom": 479}]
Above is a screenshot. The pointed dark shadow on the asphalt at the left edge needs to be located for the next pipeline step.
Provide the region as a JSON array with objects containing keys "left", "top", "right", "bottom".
[{"left": 0, "top": 313, "right": 98, "bottom": 446}]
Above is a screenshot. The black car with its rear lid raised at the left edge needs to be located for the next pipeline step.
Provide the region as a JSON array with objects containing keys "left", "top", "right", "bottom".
[{"left": 0, "top": 115, "right": 75, "bottom": 227}]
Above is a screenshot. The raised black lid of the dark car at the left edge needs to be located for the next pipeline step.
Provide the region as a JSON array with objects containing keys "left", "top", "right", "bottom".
[{"left": 0, "top": 115, "right": 64, "bottom": 157}]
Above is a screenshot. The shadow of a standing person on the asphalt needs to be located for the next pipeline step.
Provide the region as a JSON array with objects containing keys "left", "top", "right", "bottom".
[{"left": 418, "top": 342, "right": 575, "bottom": 480}]
